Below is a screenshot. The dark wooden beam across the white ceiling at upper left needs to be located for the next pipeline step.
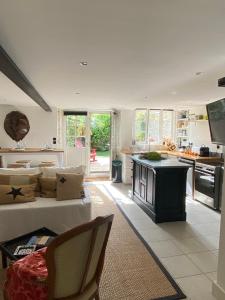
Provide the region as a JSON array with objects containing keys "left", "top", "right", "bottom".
[{"left": 0, "top": 45, "right": 52, "bottom": 111}]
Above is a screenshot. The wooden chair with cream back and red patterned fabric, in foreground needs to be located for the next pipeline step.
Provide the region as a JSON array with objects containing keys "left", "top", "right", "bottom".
[{"left": 4, "top": 215, "right": 114, "bottom": 300}]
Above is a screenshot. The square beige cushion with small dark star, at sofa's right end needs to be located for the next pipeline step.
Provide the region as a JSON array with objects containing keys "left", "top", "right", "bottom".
[{"left": 56, "top": 173, "right": 84, "bottom": 200}]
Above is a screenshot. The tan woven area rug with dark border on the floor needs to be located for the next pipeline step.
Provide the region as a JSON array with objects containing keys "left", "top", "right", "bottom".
[{"left": 87, "top": 185, "right": 185, "bottom": 300}]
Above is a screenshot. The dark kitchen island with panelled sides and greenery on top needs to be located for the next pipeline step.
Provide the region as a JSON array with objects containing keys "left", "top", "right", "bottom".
[{"left": 131, "top": 155, "right": 190, "bottom": 223}]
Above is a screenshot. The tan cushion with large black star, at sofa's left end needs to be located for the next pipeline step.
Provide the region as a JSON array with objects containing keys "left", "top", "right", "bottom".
[{"left": 0, "top": 184, "right": 36, "bottom": 204}]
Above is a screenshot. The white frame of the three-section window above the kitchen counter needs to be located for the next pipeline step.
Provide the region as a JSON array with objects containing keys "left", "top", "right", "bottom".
[{"left": 133, "top": 108, "right": 175, "bottom": 145}]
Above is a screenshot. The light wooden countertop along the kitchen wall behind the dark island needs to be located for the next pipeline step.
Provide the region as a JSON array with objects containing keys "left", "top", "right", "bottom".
[{"left": 121, "top": 150, "right": 221, "bottom": 161}]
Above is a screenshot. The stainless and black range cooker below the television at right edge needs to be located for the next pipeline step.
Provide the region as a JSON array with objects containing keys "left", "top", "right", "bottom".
[{"left": 194, "top": 162, "right": 224, "bottom": 210}]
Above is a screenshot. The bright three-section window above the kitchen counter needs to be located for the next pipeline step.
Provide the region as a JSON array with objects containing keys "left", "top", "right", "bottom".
[{"left": 134, "top": 109, "right": 173, "bottom": 144}]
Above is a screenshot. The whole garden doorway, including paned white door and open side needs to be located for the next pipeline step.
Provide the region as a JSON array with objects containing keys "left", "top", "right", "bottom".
[{"left": 64, "top": 111, "right": 112, "bottom": 177}]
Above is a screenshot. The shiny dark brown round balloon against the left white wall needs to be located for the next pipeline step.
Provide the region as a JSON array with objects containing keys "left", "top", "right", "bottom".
[{"left": 4, "top": 111, "right": 30, "bottom": 142}]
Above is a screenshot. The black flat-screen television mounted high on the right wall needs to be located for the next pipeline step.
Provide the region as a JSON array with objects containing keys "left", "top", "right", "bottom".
[{"left": 206, "top": 98, "right": 225, "bottom": 145}]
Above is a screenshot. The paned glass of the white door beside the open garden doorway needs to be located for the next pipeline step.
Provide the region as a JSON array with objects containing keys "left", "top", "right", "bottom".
[{"left": 66, "top": 115, "right": 86, "bottom": 148}]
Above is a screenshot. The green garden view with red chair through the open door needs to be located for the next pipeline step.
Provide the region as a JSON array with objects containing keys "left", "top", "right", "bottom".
[{"left": 90, "top": 112, "right": 111, "bottom": 174}]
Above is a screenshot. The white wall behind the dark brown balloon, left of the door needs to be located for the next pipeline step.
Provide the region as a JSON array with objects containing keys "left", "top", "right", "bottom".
[{"left": 0, "top": 105, "right": 57, "bottom": 161}]
